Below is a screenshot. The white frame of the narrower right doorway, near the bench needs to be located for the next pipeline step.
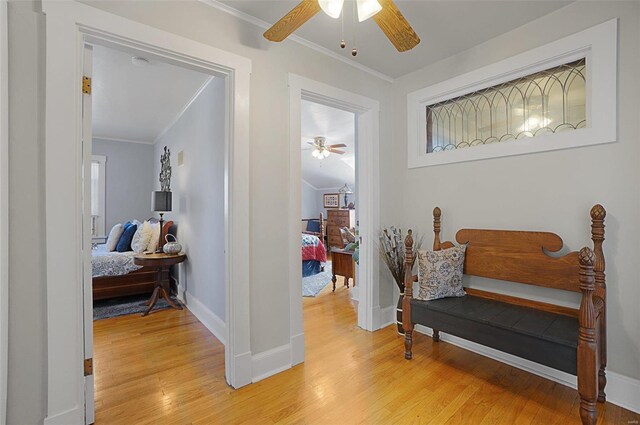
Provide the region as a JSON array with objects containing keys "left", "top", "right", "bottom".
[{"left": 289, "top": 74, "right": 381, "bottom": 365}]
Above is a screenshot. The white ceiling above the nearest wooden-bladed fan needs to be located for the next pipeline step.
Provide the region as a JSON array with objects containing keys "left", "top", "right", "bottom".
[{"left": 222, "top": 0, "right": 570, "bottom": 78}]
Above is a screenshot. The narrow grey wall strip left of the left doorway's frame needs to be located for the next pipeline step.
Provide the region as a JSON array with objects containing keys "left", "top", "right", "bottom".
[{"left": 7, "top": 2, "right": 47, "bottom": 425}]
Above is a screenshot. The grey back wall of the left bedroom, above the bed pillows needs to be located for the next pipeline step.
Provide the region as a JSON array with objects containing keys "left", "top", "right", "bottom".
[{"left": 92, "top": 139, "right": 159, "bottom": 235}]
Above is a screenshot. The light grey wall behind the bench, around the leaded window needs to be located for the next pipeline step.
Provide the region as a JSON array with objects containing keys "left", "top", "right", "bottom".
[{"left": 393, "top": 2, "right": 640, "bottom": 378}]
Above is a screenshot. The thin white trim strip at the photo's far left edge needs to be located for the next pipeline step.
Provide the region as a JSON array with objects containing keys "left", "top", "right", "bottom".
[{"left": 0, "top": 0, "right": 9, "bottom": 425}]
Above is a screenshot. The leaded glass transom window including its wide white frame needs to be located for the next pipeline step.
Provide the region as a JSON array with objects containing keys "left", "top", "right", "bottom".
[{"left": 407, "top": 19, "right": 618, "bottom": 168}]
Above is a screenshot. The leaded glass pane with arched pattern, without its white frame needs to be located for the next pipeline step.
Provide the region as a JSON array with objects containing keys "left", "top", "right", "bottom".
[{"left": 425, "top": 58, "right": 587, "bottom": 153}]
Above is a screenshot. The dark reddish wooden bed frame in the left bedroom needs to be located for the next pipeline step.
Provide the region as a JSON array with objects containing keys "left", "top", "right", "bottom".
[{"left": 92, "top": 218, "right": 175, "bottom": 301}]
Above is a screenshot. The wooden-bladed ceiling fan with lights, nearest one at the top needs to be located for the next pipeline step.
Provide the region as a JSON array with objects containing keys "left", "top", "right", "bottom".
[{"left": 264, "top": 0, "right": 420, "bottom": 56}]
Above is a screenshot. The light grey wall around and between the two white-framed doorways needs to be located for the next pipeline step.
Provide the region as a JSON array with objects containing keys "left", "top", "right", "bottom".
[{"left": 3, "top": 1, "right": 399, "bottom": 425}]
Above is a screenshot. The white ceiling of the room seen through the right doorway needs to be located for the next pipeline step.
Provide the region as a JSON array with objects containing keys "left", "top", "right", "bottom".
[{"left": 301, "top": 100, "right": 356, "bottom": 189}]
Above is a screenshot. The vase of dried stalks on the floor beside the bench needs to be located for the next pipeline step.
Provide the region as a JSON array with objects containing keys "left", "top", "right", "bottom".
[{"left": 378, "top": 226, "right": 422, "bottom": 335}]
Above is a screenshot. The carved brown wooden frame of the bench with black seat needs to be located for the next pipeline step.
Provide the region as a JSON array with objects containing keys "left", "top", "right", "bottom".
[{"left": 402, "top": 204, "right": 607, "bottom": 424}]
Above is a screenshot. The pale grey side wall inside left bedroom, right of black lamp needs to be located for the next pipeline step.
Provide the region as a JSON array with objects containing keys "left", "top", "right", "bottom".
[{"left": 153, "top": 78, "right": 225, "bottom": 320}]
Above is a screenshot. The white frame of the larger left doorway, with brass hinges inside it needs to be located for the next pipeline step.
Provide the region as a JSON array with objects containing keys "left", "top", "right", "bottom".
[{"left": 43, "top": 1, "right": 251, "bottom": 424}]
